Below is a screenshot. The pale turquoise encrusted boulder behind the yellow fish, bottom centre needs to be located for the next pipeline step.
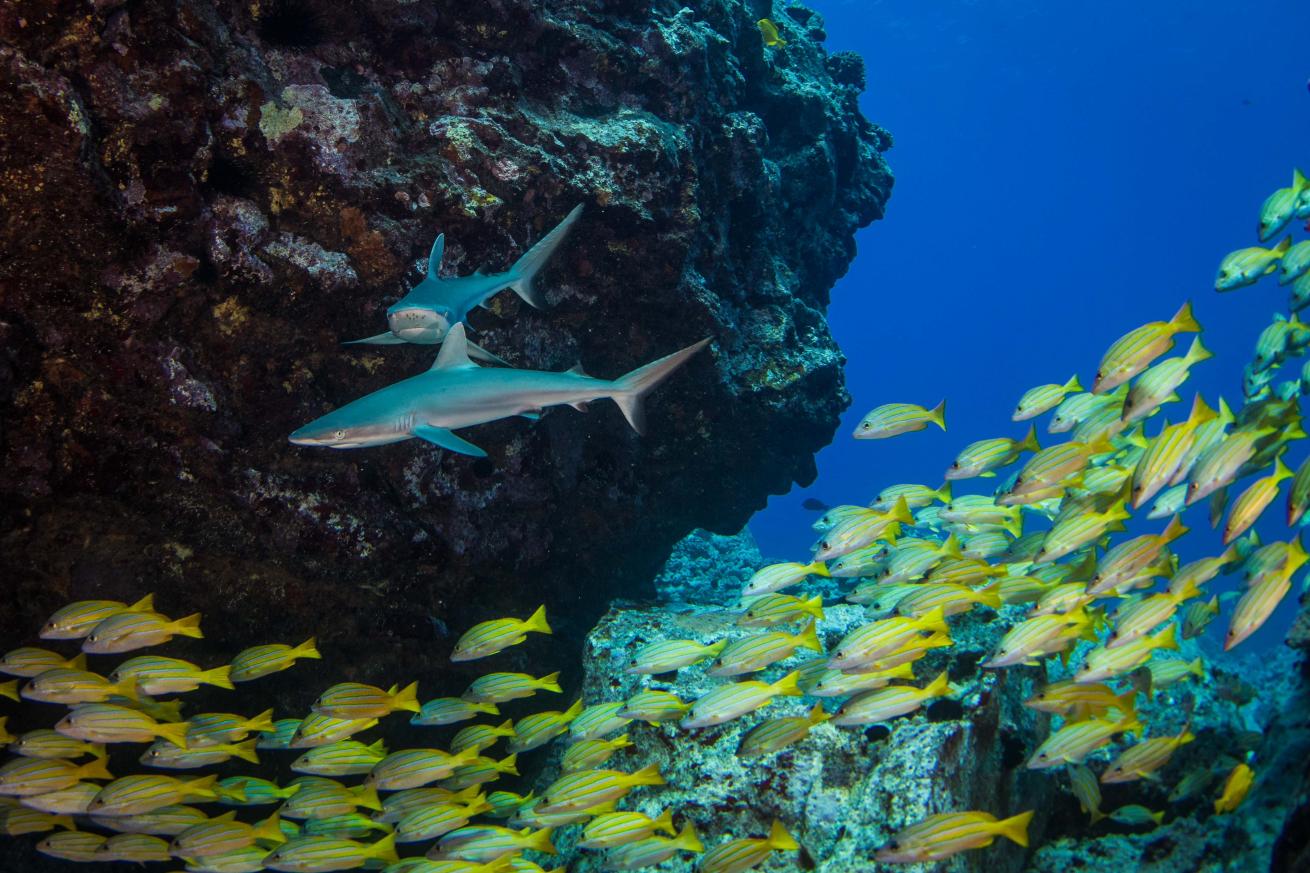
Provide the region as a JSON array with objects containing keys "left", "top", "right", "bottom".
[{"left": 538, "top": 603, "right": 1055, "bottom": 873}]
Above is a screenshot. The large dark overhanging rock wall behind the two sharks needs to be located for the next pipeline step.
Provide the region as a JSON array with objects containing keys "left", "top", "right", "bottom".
[{"left": 0, "top": 0, "right": 891, "bottom": 705}]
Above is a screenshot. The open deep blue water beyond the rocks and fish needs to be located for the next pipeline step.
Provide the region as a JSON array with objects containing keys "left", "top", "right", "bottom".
[{"left": 751, "top": 0, "right": 1310, "bottom": 648}]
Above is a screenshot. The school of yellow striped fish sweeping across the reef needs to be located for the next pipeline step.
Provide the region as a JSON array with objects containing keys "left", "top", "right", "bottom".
[{"left": 0, "top": 172, "right": 1310, "bottom": 873}]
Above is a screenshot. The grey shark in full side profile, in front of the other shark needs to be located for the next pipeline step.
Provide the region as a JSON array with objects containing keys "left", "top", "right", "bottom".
[{"left": 290, "top": 322, "right": 710, "bottom": 457}]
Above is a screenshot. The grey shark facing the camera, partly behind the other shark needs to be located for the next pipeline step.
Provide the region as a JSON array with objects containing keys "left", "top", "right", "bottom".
[{"left": 346, "top": 203, "right": 582, "bottom": 356}]
